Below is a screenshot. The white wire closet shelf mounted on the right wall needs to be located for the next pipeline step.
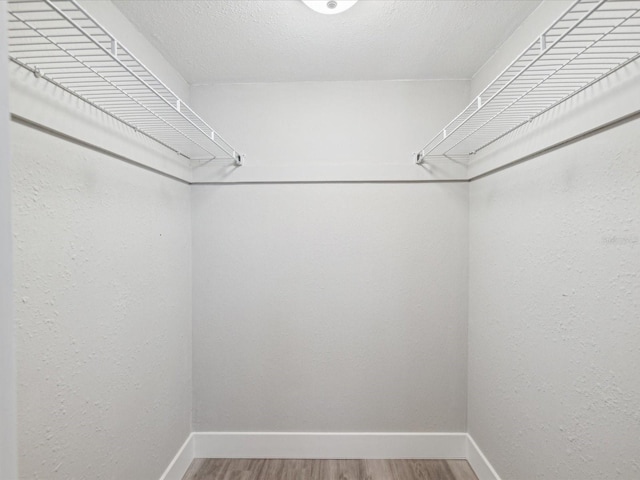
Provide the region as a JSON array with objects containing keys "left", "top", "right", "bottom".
[{"left": 416, "top": 0, "right": 640, "bottom": 164}]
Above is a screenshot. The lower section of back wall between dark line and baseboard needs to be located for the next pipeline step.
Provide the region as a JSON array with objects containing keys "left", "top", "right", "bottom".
[{"left": 192, "top": 184, "right": 468, "bottom": 432}]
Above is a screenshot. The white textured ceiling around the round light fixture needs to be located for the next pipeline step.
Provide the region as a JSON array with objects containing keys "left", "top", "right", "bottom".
[{"left": 114, "top": 0, "right": 540, "bottom": 84}]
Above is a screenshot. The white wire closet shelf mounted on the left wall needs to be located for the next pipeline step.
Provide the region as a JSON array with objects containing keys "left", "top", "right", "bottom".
[{"left": 8, "top": 0, "right": 243, "bottom": 165}]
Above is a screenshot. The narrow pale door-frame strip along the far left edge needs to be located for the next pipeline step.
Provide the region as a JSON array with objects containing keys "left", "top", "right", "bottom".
[{"left": 0, "top": 0, "right": 16, "bottom": 479}]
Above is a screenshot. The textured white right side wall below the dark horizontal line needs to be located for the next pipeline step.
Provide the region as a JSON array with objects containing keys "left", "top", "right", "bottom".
[{"left": 468, "top": 120, "right": 640, "bottom": 480}]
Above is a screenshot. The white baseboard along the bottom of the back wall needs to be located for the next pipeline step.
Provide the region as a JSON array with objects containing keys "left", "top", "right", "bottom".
[{"left": 193, "top": 432, "right": 468, "bottom": 459}]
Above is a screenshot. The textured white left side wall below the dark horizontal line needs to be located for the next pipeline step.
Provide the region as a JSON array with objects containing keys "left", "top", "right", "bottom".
[{"left": 12, "top": 124, "right": 191, "bottom": 480}]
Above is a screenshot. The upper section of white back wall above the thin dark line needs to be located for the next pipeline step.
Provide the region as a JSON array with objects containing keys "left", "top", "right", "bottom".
[{"left": 191, "top": 80, "right": 469, "bottom": 182}]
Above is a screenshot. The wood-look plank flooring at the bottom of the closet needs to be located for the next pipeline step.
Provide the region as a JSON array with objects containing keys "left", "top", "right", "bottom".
[{"left": 182, "top": 458, "right": 478, "bottom": 480}]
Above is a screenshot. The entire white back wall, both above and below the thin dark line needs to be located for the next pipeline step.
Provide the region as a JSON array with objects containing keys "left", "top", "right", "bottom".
[{"left": 191, "top": 81, "right": 468, "bottom": 432}]
